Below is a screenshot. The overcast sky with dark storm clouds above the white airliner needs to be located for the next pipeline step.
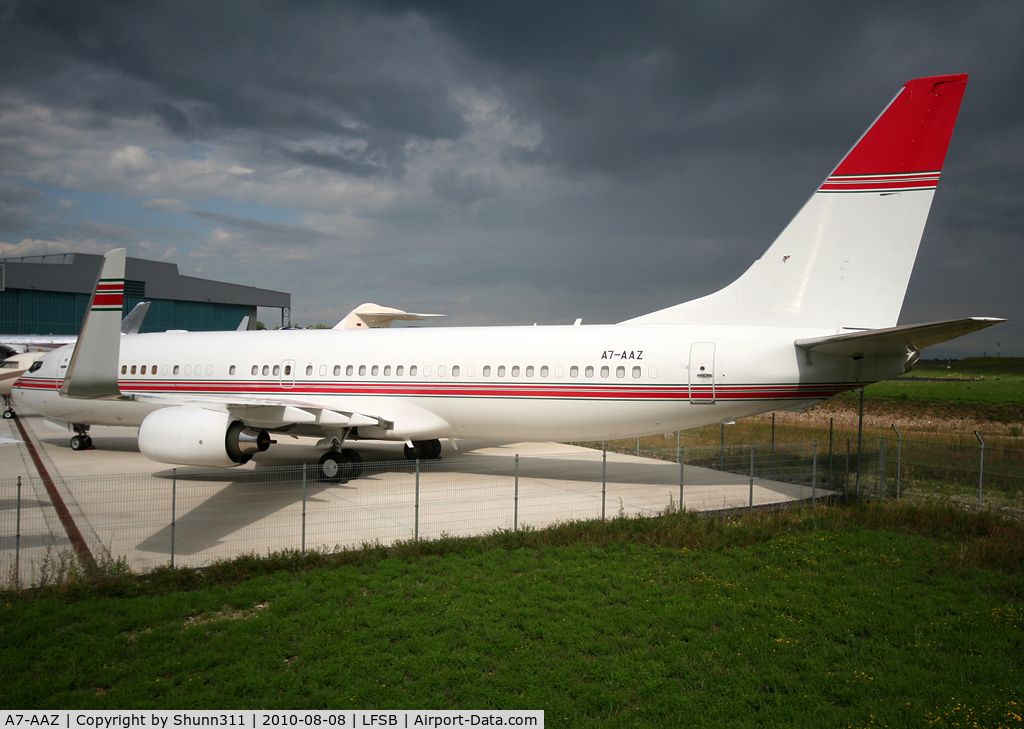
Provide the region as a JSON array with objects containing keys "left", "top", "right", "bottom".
[{"left": 0, "top": 0, "right": 1024, "bottom": 356}]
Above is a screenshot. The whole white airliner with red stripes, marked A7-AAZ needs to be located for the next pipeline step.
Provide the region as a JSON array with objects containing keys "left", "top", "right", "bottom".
[{"left": 14, "top": 75, "right": 1004, "bottom": 480}]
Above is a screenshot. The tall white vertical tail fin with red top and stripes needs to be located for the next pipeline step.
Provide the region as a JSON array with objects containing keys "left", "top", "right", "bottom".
[{"left": 624, "top": 74, "right": 967, "bottom": 332}]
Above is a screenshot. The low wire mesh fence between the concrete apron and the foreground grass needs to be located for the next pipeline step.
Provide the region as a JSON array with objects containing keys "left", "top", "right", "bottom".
[{"left": 0, "top": 443, "right": 827, "bottom": 585}]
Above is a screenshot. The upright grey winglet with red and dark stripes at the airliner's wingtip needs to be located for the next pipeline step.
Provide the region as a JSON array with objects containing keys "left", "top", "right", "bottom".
[{"left": 60, "top": 248, "right": 125, "bottom": 398}]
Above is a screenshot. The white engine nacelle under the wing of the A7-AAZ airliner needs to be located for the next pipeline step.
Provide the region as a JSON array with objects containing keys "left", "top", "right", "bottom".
[{"left": 138, "top": 408, "right": 272, "bottom": 466}]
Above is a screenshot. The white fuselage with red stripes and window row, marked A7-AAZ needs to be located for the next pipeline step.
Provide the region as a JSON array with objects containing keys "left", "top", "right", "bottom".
[{"left": 14, "top": 325, "right": 906, "bottom": 440}]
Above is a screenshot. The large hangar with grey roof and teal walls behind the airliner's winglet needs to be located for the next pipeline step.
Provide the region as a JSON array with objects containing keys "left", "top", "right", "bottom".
[{"left": 0, "top": 253, "right": 292, "bottom": 335}]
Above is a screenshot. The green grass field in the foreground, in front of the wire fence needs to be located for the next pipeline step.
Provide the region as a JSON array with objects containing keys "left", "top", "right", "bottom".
[{"left": 0, "top": 504, "right": 1024, "bottom": 727}]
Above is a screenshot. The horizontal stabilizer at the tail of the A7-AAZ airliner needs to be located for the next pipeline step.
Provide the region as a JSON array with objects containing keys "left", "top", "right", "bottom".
[{"left": 794, "top": 316, "right": 1006, "bottom": 357}]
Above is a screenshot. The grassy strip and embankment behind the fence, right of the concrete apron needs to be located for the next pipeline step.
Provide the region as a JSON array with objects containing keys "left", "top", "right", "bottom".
[{"left": 587, "top": 357, "right": 1024, "bottom": 513}]
